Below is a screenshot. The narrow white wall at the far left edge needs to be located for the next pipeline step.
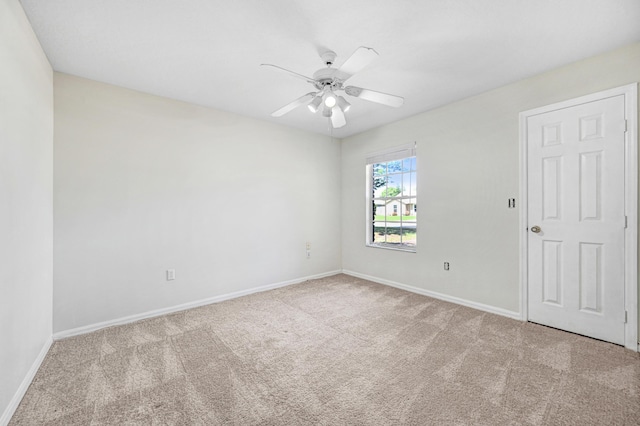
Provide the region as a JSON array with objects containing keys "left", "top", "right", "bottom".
[{"left": 0, "top": 0, "right": 53, "bottom": 424}]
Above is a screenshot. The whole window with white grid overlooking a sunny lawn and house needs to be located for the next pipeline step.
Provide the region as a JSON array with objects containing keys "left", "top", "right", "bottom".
[{"left": 367, "top": 144, "right": 418, "bottom": 251}]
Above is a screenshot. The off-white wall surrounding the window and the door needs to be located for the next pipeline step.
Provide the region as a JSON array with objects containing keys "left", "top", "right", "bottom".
[{"left": 342, "top": 44, "right": 640, "bottom": 312}]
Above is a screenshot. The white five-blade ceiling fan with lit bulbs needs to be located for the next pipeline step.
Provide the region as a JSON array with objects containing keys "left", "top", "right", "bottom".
[{"left": 261, "top": 46, "right": 404, "bottom": 129}]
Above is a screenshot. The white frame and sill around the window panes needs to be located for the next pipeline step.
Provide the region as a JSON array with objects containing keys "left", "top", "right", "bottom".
[{"left": 365, "top": 142, "right": 419, "bottom": 253}]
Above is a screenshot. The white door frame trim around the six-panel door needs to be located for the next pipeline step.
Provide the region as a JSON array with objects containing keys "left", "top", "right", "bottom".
[{"left": 519, "top": 83, "right": 640, "bottom": 352}]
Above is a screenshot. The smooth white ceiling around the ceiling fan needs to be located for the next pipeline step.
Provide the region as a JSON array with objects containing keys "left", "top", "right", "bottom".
[{"left": 21, "top": 0, "right": 640, "bottom": 137}]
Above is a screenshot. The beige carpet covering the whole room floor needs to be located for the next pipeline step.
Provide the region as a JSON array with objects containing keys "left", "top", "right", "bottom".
[{"left": 10, "top": 275, "right": 640, "bottom": 425}]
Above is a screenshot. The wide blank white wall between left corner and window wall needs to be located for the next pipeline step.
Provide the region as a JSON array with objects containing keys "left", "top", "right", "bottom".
[{"left": 54, "top": 73, "right": 341, "bottom": 332}]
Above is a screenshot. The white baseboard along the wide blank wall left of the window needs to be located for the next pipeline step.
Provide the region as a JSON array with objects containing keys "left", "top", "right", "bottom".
[{"left": 53, "top": 270, "right": 341, "bottom": 340}]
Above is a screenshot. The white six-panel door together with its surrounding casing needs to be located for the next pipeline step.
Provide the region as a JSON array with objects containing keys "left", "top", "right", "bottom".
[{"left": 521, "top": 85, "right": 638, "bottom": 350}]
